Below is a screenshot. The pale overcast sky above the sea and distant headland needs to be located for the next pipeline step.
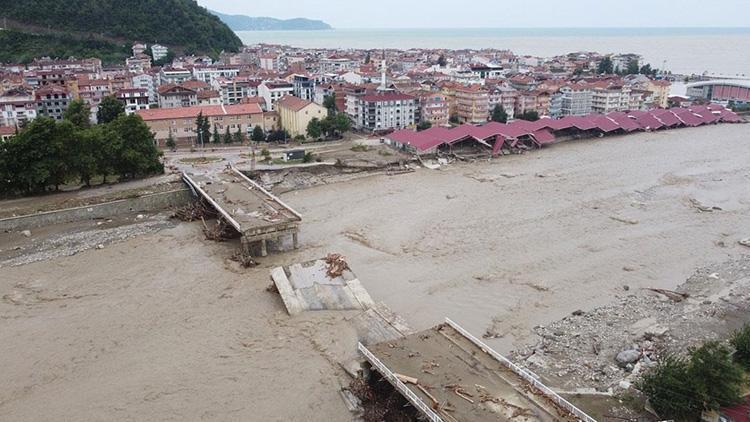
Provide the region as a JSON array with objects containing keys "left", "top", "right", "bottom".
[{"left": 198, "top": 0, "right": 750, "bottom": 28}]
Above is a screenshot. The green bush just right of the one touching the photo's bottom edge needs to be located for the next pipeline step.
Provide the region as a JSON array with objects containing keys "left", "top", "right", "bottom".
[{"left": 690, "top": 341, "right": 745, "bottom": 410}]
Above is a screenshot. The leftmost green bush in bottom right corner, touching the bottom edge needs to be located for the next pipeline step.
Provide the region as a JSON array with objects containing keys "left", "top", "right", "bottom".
[{"left": 636, "top": 356, "right": 702, "bottom": 420}]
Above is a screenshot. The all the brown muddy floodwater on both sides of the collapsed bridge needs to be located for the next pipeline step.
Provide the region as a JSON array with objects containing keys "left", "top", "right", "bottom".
[{"left": 0, "top": 125, "right": 750, "bottom": 421}]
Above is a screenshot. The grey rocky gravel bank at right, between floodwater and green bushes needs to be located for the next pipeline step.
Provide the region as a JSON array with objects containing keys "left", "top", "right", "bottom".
[{"left": 513, "top": 254, "right": 750, "bottom": 393}]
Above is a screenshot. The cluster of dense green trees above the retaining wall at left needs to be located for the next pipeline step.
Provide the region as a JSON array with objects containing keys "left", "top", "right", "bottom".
[{"left": 0, "top": 97, "right": 164, "bottom": 196}]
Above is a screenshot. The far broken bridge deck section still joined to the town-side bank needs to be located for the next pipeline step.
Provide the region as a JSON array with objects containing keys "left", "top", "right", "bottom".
[{"left": 183, "top": 167, "right": 302, "bottom": 254}]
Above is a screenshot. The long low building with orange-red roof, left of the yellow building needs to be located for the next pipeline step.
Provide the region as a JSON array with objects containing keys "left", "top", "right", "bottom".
[{"left": 136, "top": 104, "right": 272, "bottom": 147}]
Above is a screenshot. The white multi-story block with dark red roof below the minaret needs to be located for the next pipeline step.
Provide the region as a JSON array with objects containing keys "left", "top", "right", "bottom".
[{"left": 347, "top": 92, "right": 419, "bottom": 130}]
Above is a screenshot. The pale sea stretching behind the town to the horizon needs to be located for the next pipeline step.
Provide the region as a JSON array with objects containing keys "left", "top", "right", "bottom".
[{"left": 237, "top": 27, "right": 750, "bottom": 78}]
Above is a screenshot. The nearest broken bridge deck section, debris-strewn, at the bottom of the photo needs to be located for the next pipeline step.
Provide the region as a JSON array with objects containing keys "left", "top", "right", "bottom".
[{"left": 360, "top": 323, "right": 590, "bottom": 422}]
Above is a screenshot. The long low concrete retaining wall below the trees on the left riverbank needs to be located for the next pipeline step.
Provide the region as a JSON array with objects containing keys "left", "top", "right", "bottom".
[{"left": 0, "top": 189, "right": 192, "bottom": 231}]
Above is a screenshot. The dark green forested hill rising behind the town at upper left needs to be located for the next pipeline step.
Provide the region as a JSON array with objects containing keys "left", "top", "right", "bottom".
[{"left": 0, "top": 0, "right": 242, "bottom": 62}]
